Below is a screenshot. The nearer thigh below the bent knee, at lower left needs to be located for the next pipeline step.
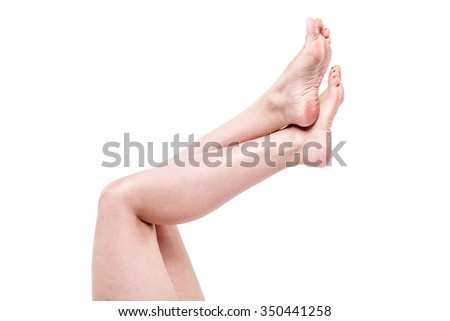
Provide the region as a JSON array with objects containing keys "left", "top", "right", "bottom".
[{"left": 92, "top": 206, "right": 178, "bottom": 301}]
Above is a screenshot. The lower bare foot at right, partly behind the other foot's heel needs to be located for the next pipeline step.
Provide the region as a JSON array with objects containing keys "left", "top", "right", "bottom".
[{"left": 290, "top": 66, "right": 344, "bottom": 167}]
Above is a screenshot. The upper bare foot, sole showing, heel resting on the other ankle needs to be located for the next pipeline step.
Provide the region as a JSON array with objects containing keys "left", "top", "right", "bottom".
[{"left": 273, "top": 19, "right": 331, "bottom": 127}]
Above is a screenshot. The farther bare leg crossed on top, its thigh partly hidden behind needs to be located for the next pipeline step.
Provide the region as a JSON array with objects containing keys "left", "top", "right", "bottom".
[{"left": 157, "top": 19, "right": 331, "bottom": 299}]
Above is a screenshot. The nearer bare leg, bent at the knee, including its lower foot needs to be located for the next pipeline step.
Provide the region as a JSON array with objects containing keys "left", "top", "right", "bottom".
[{"left": 93, "top": 68, "right": 343, "bottom": 300}]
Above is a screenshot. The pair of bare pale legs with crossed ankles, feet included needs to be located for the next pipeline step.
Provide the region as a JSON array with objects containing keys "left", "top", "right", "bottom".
[{"left": 92, "top": 19, "right": 344, "bottom": 300}]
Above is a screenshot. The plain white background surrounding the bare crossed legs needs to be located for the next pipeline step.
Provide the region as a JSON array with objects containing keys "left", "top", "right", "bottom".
[{"left": 0, "top": 1, "right": 450, "bottom": 321}]
